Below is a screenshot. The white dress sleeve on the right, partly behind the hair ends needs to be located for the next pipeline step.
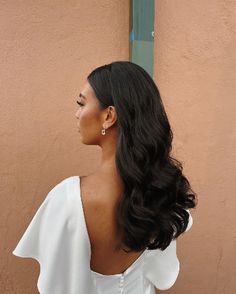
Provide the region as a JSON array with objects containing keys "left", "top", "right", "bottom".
[{"left": 144, "top": 210, "right": 193, "bottom": 290}]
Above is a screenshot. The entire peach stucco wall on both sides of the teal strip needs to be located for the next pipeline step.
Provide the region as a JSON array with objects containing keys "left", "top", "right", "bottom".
[{"left": 0, "top": 0, "right": 236, "bottom": 294}]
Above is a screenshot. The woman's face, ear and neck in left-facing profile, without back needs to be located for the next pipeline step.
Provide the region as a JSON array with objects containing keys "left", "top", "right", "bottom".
[{"left": 75, "top": 81, "right": 118, "bottom": 178}]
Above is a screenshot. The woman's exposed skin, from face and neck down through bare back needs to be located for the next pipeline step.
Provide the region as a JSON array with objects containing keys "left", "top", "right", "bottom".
[{"left": 75, "top": 81, "right": 145, "bottom": 275}]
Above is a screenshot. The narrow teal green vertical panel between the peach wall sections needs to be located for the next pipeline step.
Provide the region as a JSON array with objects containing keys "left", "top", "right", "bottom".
[{"left": 130, "top": 0, "right": 154, "bottom": 76}]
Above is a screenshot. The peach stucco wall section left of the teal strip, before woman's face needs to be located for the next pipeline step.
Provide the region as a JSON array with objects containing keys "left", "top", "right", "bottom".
[{"left": 0, "top": 0, "right": 129, "bottom": 294}]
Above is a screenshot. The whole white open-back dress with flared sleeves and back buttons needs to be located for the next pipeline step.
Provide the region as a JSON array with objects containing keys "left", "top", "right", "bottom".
[{"left": 12, "top": 176, "right": 193, "bottom": 294}]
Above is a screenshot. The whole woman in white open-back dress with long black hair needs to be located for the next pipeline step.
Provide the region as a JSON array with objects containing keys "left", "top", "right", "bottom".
[{"left": 13, "top": 61, "right": 196, "bottom": 294}]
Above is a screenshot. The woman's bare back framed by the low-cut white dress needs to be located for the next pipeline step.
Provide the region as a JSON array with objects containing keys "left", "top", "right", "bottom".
[{"left": 80, "top": 173, "right": 146, "bottom": 275}]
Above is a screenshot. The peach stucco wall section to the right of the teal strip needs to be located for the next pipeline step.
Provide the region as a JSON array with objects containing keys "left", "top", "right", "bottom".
[{"left": 154, "top": 0, "right": 236, "bottom": 294}]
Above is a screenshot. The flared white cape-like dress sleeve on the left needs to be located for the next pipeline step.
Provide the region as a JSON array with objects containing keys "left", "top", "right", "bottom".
[{"left": 12, "top": 177, "right": 93, "bottom": 294}]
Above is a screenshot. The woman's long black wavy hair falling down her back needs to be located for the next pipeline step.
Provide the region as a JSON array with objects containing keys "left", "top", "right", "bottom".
[{"left": 87, "top": 61, "right": 196, "bottom": 252}]
